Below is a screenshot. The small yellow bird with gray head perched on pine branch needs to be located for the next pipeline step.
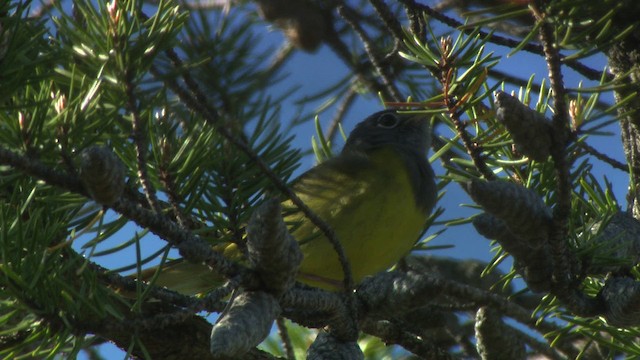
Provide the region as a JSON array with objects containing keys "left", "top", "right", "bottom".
[{"left": 143, "top": 110, "right": 437, "bottom": 294}]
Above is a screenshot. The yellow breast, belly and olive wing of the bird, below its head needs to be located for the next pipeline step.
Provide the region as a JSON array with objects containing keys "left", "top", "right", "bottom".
[{"left": 285, "top": 147, "right": 428, "bottom": 289}]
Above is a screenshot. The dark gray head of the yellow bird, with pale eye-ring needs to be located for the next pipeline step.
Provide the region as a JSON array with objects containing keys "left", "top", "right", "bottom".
[{"left": 343, "top": 110, "right": 431, "bottom": 156}]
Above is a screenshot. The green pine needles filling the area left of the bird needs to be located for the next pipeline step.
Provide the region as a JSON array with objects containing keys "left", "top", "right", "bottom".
[{"left": 0, "top": 1, "right": 299, "bottom": 358}]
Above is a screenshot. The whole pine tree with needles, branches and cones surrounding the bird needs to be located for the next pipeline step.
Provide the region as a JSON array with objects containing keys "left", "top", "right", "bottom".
[{"left": 0, "top": 0, "right": 640, "bottom": 359}]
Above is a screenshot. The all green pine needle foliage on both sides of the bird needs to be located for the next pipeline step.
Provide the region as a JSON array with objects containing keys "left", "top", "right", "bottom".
[{"left": 0, "top": 0, "right": 640, "bottom": 359}]
